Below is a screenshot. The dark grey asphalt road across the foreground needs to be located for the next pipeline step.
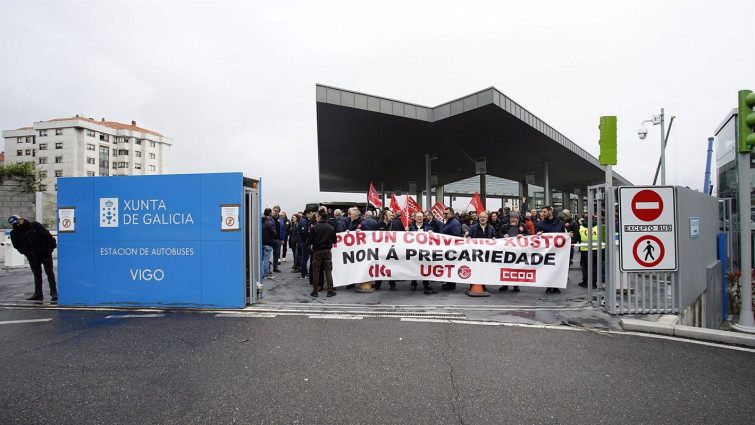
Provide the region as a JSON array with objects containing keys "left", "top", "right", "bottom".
[{"left": 0, "top": 309, "right": 755, "bottom": 424}]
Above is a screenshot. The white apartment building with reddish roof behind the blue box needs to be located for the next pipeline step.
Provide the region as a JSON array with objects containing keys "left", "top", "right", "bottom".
[{"left": 3, "top": 115, "right": 173, "bottom": 192}]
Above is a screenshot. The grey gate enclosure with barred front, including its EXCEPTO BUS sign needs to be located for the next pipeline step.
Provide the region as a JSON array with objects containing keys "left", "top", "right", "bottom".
[{"left": 587, "top": 185, "right": 726, "bottom": 328}]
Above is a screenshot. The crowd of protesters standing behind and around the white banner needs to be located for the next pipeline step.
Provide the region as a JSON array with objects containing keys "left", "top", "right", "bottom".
[{"left": 262, "top": 201, "right": 598, "bottom": 297}]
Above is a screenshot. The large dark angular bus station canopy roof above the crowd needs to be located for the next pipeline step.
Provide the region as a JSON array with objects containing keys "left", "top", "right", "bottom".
[{"left": 316, "top": 84, "right": 630, "bottom": 193}]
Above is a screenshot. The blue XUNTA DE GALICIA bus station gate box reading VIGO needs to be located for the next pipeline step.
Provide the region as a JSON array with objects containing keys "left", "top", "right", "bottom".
[{"left": 58, "top": 173, "right": 261, "bottom": 308}]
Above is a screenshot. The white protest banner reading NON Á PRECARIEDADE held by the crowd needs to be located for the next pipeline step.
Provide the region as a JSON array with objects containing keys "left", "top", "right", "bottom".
[{"left": 332, "top": 231, "right": 571, "bottom": 288}]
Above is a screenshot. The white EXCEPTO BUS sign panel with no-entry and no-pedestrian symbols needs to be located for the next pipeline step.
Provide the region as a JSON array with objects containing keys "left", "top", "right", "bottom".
[{"left": 619, "top": 186, "right": 677, "bottom": 272}]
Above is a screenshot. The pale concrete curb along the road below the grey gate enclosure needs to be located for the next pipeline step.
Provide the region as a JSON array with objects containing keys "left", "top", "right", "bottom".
[{"left": 620, "top": 319, "right": 755, "bottom": 347}]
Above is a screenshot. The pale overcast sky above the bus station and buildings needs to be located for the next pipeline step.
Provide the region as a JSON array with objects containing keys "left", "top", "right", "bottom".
[{"left": 0, "top": 0, "right": 755, "bottom": 211}]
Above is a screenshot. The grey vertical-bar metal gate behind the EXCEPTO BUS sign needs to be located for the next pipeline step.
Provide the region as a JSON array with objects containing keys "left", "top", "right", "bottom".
[{"left": 587, "top": 184, "right": 679, "bottom": 314}]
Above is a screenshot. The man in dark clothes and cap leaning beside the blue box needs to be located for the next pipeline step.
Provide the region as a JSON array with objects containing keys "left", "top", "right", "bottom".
[{"left": 8, "top": 215, "right": 58, "bottom": 301}]
